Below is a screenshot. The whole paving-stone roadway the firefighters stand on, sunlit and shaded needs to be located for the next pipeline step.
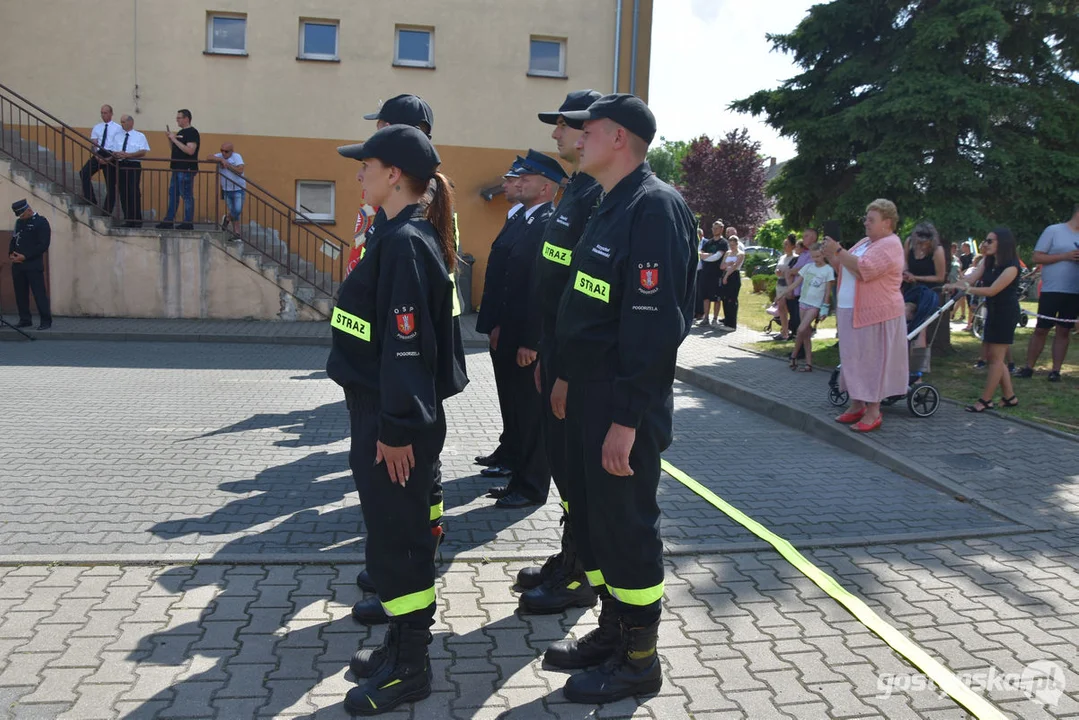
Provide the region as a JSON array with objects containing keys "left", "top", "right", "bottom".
[{"left": 0, "top": 340, "right": 1079, "bottom": 720}]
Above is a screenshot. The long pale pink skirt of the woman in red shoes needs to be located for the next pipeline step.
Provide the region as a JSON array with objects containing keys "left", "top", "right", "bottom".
[{"left": 835, "top": 308, "right": 910, "bottom": 403}]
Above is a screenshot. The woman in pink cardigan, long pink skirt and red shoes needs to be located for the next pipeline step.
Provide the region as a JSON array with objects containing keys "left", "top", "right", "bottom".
[{"left": 824, "top": 200, "right": 907, "bottom": 433}]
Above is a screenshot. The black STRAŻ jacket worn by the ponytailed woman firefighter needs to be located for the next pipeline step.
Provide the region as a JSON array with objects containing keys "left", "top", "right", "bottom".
[{"left": 326, "top": 205, "right": 468, "bottom": 447}]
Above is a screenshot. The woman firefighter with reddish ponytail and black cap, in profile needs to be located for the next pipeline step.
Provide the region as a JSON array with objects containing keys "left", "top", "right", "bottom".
[{"left": 326, "top": 125, "right": 467, "bottom": 715}]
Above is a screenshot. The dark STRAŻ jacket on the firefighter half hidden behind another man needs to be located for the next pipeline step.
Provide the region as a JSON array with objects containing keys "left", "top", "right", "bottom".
[{"left": 533, "top": 173, "right": 603, "bottom": 375}]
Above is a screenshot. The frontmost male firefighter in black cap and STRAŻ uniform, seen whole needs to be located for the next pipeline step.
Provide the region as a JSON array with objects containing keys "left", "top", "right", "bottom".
[{"left": 544, "top": 95, "right": 696, "bottom": 703}]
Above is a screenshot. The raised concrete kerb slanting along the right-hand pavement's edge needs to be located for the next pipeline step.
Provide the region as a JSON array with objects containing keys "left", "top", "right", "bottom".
[{"left": 674, "top": 365, "right": 1053, "bottom": 531}]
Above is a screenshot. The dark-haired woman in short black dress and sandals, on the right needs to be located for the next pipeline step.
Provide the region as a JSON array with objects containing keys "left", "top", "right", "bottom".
[{"left": 946, "top": 228, "right": 1020, "bottom": 412}]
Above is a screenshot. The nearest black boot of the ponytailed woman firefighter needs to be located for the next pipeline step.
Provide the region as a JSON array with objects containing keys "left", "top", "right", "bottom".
[{"left": 344, "top": 622, "right": 432, "bottom": 716}]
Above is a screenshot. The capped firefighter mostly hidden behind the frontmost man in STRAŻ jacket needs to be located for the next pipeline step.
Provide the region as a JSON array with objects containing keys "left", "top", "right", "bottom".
[{"left": 517, "top": 90, "right": 602, "bottom": 613}]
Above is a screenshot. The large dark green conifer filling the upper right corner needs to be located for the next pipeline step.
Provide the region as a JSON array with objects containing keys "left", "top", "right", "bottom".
[{"left": 732, "top": 0, "right": 1079, "bottom": 242}]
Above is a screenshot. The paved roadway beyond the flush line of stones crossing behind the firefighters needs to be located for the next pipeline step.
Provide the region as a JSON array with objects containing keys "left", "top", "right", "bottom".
[{"left": 0, "top": 342, "right": 1014, "bottom": 561}]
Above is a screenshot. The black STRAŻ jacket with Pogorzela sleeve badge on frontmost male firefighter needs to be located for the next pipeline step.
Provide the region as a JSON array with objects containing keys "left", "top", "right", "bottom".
[{"left": 556, "top": 163, "right": 697, "bottom": 427}]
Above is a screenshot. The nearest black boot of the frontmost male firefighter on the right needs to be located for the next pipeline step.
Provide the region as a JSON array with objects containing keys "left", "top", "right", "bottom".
[{"left": 562, "top": 622, "right": 664, "bottom": 705}]
